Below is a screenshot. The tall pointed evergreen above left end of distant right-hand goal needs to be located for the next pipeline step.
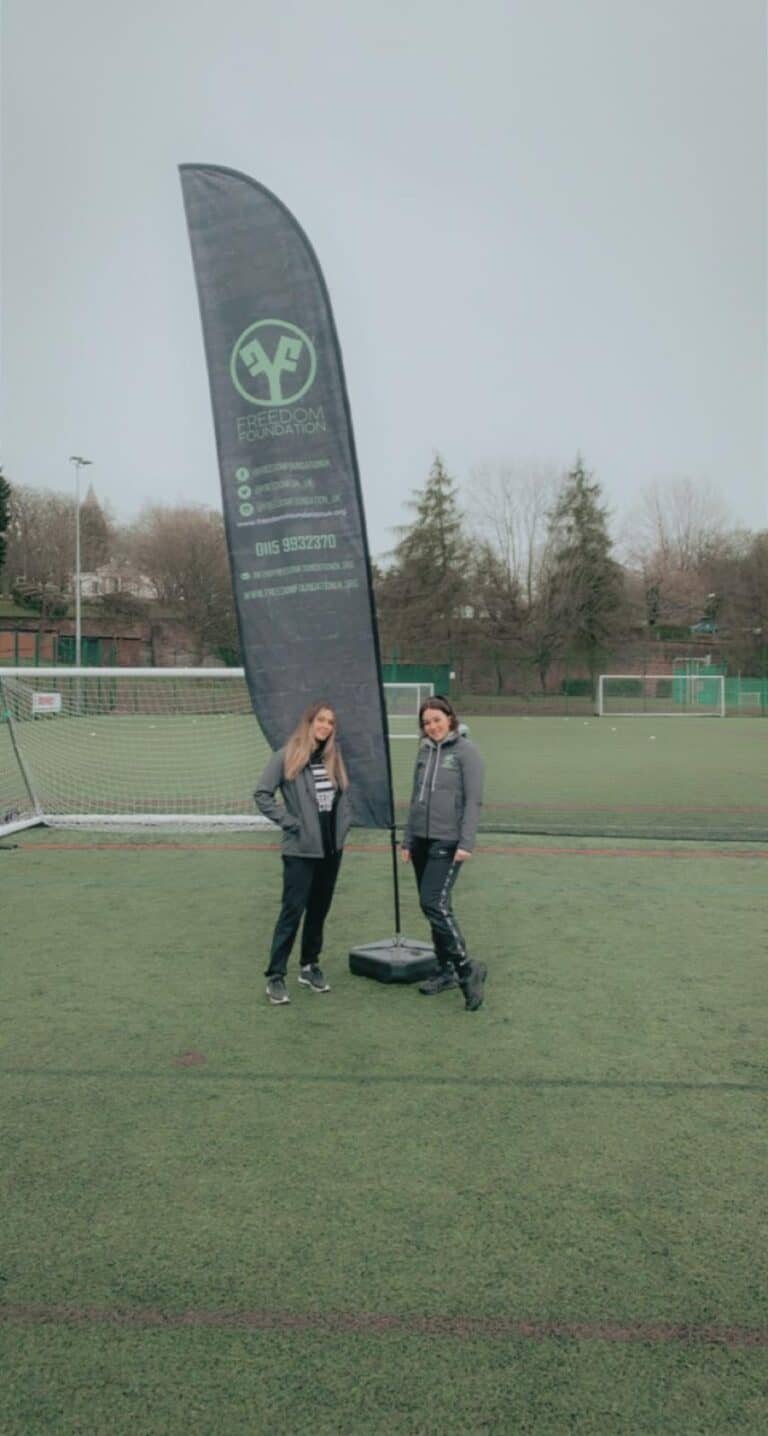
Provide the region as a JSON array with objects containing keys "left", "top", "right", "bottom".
[{"left": 543, "top": 455, "right": 624, "bottom": 678}]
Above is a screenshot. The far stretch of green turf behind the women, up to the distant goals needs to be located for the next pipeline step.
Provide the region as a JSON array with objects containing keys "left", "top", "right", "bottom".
[{"left": 0, "top": 715, "right": 768, "bottom": 841}]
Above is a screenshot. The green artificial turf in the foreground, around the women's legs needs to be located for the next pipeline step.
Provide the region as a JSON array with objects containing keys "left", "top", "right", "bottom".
[{"left": 0, "top": 827, "right": 768, "bottom": 1436}]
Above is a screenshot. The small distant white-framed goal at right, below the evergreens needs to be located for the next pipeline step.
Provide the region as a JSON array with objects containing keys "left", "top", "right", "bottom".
[{"left": 597, "top": 673, "right": 725, "bottom": 718}]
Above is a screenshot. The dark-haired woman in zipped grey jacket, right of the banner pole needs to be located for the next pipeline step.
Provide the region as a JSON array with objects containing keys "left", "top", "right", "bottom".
[{"left": 401, "top": 695, "right": 487, "bottom": 1012}]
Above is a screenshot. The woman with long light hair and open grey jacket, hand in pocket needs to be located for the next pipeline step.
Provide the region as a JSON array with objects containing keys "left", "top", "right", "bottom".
[{"left": 254, "top": 704, "right": 350, "bottom": 1004}]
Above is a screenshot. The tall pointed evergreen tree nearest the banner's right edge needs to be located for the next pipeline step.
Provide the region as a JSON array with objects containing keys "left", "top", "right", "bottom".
[{"left": 378, "top": 455, "right": 471, "bottom": 662}]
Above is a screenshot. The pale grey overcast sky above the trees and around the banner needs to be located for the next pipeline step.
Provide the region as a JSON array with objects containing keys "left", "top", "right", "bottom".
[{"left": 1, "top": 0, "right": 768, "bottom": 554}]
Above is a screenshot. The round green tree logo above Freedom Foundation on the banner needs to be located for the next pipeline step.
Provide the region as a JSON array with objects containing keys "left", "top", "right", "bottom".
[{"left": 230, "top": 319, "right": 317, "bottom": 409}]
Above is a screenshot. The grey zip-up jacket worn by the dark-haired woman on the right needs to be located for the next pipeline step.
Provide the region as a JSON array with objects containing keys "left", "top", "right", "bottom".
[{"left": 402, "top": 732, "right": 485, "bottom": 853}]
